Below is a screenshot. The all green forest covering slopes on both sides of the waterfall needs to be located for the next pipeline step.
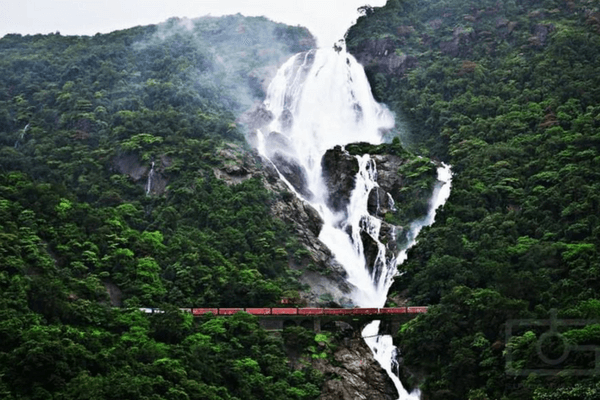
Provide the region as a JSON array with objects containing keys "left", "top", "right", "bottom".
[{"left": 0, "top": 0, "right": 600, "bottom": 400}]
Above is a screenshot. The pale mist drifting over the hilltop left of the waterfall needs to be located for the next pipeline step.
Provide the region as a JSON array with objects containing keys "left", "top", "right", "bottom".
[{"left": 133, "top": 14, "right": 316, "bottom": 113}]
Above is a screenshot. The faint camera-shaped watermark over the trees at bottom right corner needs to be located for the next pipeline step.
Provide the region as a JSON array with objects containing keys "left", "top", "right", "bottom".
[{"left": 506, "top": 310, "right": 600, "bottom": 376}]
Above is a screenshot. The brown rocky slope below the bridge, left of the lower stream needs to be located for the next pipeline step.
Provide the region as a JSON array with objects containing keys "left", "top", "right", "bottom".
[{"left": 313, "top": 329, "right": 398, "bottom": 400}]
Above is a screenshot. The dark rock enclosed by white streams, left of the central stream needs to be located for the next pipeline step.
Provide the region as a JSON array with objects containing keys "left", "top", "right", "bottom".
[{"left": 321, "top": 146, "right": 358, "bottom": 212}]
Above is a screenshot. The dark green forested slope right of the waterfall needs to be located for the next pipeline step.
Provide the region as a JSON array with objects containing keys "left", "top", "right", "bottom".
[{"left": 346, "top": 0, "right": 600, "bottom": 400}]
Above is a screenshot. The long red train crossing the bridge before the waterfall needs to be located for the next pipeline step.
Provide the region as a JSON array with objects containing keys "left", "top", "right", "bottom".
[{"left": 140, "top": 307, "right": 427, "bottom": 316}]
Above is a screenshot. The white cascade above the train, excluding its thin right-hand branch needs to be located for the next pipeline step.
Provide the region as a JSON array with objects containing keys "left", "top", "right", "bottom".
[{"left": 259, "top": 49, "right": 394, "bottom": 306}]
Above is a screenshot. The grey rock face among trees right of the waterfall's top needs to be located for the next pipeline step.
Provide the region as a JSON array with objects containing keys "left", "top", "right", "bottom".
[{"left": 353, "top": 36, "right": 418, "bottom": 76}]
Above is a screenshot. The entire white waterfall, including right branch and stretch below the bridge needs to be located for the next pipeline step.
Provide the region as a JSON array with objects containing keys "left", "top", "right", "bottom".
[{"left": 257, "top": 48, "right": 450, "bottom": 399}]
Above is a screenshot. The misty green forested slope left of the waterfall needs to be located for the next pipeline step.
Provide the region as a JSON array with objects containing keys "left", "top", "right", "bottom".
[{"left": 0, "top": 15, "right": 323, "bottom": 400}]
